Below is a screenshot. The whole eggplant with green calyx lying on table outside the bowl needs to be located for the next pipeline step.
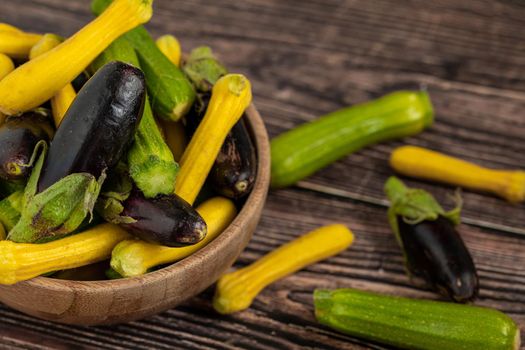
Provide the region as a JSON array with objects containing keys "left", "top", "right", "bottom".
[{"left": 385, "top": 177, "right": 479, "bottom": 302}]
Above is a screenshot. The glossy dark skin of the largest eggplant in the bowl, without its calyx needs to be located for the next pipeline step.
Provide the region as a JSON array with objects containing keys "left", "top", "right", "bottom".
[{"left": 38, "top": 62, "right": 146, "bottom": 192}]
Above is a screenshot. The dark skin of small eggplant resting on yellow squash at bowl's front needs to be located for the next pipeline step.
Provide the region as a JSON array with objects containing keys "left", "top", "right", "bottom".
[{"left": 120, "top": 190, "right": 207, "bottom": 247}]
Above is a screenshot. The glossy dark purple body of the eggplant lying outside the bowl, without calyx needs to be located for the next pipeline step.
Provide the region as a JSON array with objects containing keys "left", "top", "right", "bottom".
[{"left": 397, "top": 216, "right": 479, "bottom": 302}]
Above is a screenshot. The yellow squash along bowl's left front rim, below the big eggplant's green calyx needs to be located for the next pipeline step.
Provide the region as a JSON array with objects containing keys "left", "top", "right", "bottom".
[{"left": 0, "top": 224, "right": 131, "bottom": 284}]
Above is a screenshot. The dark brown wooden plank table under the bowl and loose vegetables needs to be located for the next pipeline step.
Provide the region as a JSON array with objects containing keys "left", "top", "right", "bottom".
[{"left": 0, "top": 0, "right": 525, "bottom": 349}]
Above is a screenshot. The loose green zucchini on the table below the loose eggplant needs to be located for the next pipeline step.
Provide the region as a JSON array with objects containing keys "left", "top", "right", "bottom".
[{"left": 314, "top": 289, "right": 520, "bottom": 350}]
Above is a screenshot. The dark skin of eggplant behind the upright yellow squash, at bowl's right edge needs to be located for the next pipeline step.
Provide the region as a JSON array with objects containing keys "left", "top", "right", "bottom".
[{"left": 186, "top": 94, "right": 257, "bottom": 199}]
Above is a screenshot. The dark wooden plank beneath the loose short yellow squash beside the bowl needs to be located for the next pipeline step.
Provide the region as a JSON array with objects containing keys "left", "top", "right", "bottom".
[{"left": 0, "top": 189, "right": 525, "bottom": 349}]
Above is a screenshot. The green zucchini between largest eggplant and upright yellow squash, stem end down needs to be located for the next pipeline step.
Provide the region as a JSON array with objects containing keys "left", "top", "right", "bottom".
[{"left": 91, "top": 38, "right": 179, "bottom": 198}]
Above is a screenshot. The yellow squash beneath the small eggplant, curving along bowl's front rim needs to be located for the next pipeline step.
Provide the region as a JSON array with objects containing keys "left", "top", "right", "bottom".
[{"left": 111, "top": 197, "right": 237, "bottom": 277}]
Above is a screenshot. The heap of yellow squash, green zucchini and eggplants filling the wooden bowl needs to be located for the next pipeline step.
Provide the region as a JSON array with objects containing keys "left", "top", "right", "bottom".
[{"left": 0, "top": 0, "right": 257, "bottom": 284}]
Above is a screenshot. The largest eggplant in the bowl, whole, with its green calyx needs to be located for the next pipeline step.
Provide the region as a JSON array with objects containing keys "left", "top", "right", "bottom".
[{"left": 8, "top": 62, "right": 146, "bottom": 243}]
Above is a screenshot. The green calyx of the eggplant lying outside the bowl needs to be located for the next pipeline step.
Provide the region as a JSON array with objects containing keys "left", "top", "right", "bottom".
[{"left": 385, "top": 176, "right": 462, "bottom": 243}]
